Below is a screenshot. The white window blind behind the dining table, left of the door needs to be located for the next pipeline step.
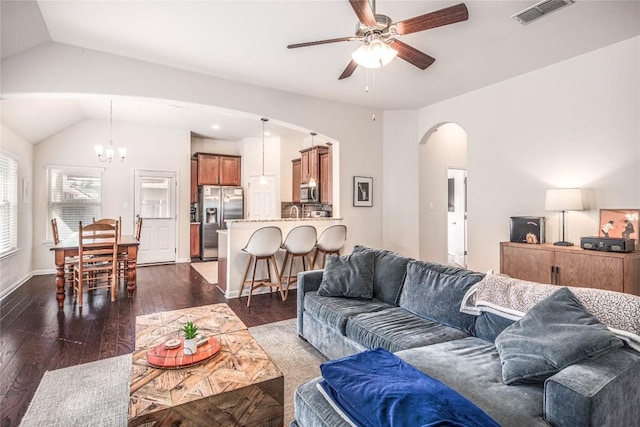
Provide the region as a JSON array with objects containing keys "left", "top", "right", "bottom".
[{"left": 47, "top": 166, "right": 102, "bottom": 241}]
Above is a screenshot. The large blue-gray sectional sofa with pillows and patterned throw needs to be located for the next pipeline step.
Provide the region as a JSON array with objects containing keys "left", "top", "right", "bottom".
[{"left": 292, "top": 246, "right": 640, "bottom": 427}]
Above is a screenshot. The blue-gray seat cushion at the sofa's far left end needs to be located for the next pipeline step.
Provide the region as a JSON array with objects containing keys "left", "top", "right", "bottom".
[{"left": 304, "top": 292, "right": 391, "bottom": 335}]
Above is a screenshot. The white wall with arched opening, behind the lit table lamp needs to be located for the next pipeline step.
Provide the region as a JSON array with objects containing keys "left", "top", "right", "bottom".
[{"left": 384, "top": 37, "right": 640, "bottom": 271}]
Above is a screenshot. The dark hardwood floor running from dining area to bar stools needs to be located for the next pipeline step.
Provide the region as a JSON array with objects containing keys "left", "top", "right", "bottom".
[{"left": 0, "top": 264, "right": 296, "bottom": 427}]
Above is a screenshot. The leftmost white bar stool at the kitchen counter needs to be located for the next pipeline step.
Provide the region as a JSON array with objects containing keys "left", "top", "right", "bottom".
[{"left": 240, "top": 227, "right": 285, "bottom": 307}]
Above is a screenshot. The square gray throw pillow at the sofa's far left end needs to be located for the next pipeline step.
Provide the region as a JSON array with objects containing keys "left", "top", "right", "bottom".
[{"left": 318, "top": 251, "right": 375, "bottom": 299}]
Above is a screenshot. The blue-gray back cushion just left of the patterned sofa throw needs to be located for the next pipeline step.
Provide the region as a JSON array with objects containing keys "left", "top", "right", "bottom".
[{"left": 400, "top": 261, "right": 484, "bottom": 333}]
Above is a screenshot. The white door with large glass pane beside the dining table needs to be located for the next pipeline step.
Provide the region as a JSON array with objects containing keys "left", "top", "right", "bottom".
[{"left": 134, "top": 170, "right": 176, "bottom": 264}]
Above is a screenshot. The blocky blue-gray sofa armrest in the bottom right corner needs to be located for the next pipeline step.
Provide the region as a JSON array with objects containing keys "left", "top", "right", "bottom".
[{"left": 544, "top": 348, "right": 640, "bottom": 427}]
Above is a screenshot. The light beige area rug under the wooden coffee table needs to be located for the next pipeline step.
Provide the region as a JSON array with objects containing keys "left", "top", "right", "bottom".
[{"left": 20, "top": 319, "right": 326, "bottom": 427}]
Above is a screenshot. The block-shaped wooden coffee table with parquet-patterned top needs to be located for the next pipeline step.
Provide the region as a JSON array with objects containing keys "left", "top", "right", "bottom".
[{"left": 129, "top": 304, "right": 284, "bottom": 427}]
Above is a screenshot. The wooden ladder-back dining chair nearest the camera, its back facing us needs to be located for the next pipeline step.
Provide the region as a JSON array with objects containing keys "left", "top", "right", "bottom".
[{"left": 73, "top": 221, "right": 118, "bottom": 308}]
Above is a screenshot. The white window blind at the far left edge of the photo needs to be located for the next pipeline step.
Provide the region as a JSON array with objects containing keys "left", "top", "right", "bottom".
[{"left": 0, "top": 152, "right": 18, "bottom": 257}]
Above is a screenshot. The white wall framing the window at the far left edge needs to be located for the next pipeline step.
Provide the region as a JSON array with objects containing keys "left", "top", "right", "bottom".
[{"left": 0, "top": 126, "right": 33, "bottom": 298}]
